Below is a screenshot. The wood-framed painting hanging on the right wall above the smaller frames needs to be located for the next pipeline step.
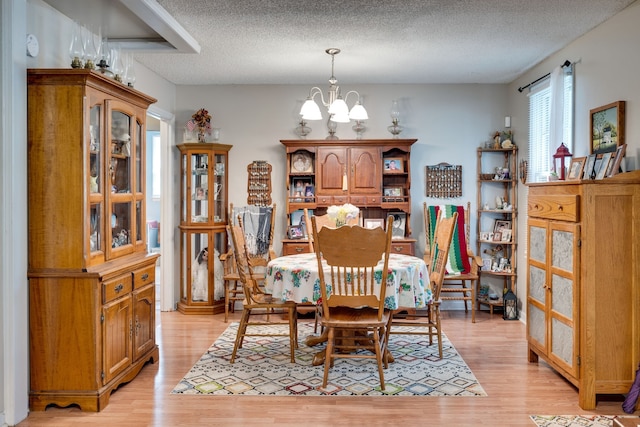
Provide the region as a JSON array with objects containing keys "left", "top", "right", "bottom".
[{"left": 589, "top": 101, "right": 625, "bottom": 154}]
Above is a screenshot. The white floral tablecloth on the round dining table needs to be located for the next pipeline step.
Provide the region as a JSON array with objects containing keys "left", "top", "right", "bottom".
[{"left": 265, "top": 253, "right": 433, "bottom": 310}]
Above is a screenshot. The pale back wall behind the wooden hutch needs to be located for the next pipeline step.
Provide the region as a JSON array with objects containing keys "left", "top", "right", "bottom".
[{"left": 176, "top": 83, "right": 508, "bottom": 254}]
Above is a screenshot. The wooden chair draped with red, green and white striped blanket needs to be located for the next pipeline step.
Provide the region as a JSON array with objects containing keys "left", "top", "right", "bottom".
[{"left": 423, "top": 202, "right": 482, "bottom": 323}]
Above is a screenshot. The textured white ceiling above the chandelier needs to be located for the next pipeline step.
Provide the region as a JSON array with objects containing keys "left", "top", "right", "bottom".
[{"left": 47, "top": 0, "right": 634, "bottom": 85}]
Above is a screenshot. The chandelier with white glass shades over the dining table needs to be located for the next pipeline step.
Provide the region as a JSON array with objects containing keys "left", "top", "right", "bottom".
[{"left": 300, "top": 48, "right": 369, "bottom": 126}]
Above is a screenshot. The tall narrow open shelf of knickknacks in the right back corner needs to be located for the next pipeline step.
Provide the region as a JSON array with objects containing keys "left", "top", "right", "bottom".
[{"left": 476, "top": 145, "right": 518, "bottom": 312}]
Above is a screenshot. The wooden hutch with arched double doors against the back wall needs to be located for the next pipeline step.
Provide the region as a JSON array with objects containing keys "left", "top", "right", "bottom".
[{"left": 280, "top": 139, "right": 416, "bottom": 255}]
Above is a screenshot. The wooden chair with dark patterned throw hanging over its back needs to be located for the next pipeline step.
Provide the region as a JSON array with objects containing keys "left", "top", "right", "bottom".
[{"left": 220, "top": 203, "right": 276, "bottom": 323}]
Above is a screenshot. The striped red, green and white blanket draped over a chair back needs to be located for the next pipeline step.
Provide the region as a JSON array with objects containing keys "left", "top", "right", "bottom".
[{"left": 427, "top": 205, "right": 471, "bottom": 275}]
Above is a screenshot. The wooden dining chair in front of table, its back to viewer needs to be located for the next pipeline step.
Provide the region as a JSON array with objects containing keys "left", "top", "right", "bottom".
[{"left": 311, "top": 217, "right": 393, "bottom": 390}]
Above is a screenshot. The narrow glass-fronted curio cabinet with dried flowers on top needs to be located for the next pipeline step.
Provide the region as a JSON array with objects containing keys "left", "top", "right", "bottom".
[{"left": 178, "top": 142, "right": 232, "bottom": 314}]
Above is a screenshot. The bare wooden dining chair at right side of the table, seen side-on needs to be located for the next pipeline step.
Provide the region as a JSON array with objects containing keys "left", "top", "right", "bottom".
[{"left": 390, "top": 212, "right": 458, "bottom": 359}]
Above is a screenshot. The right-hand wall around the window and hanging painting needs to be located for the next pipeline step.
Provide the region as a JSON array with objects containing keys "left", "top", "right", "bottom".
[{"left": 508, "top": 2, "right": 640, "bottom": 321}]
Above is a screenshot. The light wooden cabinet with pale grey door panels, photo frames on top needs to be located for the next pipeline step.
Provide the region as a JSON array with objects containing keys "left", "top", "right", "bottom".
[{"left": 526, "top": 171, "right": 640, "bottom": 410}]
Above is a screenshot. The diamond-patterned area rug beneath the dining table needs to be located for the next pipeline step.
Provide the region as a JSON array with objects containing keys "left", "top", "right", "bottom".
[{"left": 171, "top": 322, "right": 486, "bottom": 396}]
